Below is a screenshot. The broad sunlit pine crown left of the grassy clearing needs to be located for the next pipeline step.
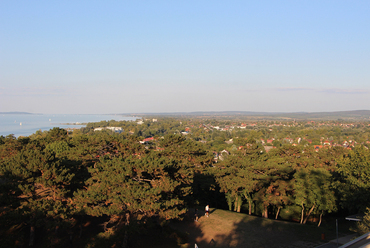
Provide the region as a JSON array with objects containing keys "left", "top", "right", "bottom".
[{"left": 75, "top": 152, "right": 191, "bottom": 227}]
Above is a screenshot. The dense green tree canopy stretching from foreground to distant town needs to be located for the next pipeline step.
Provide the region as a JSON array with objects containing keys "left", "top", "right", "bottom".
[{"left": 0, "top": 118, "right": 370, "bottom": 246}]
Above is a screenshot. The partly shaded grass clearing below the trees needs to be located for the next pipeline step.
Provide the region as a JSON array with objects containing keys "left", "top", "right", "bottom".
[{"left": 165, "top": 209, "right": 353, "bottom": 248}]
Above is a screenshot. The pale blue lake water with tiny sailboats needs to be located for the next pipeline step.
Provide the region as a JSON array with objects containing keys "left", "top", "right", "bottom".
[{"left": 0, "top": 114, "right": 137, "bottom": 137}]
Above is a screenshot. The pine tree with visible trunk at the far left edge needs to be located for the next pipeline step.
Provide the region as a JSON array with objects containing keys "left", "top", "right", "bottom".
[{"left": 0, "top": 142, "right": 74, "bottom": 244}]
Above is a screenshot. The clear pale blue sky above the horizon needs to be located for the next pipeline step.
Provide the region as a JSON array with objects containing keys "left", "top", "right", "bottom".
[{"left": 0, "top": 0, "right": 370, "bottom": 114}]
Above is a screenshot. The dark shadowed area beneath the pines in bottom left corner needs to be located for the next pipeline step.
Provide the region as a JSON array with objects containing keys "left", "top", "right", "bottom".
[{"left": 0, "top": 206, "right": 111, "bottom": 248}]
